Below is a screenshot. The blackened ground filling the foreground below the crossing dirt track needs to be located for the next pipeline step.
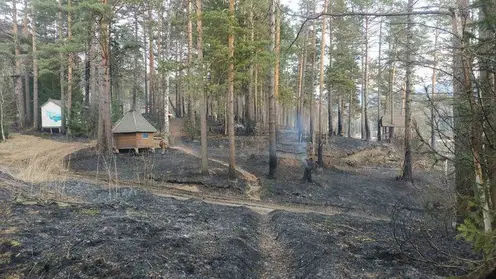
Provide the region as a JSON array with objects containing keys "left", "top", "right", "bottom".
[{"left": 0, "top": 173, "right": 472, "bottom": 279}]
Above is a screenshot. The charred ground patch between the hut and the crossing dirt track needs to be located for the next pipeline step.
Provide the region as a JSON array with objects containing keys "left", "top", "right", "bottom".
[{"left": 66, "top": 149, "right": 246, "bottom": 195}]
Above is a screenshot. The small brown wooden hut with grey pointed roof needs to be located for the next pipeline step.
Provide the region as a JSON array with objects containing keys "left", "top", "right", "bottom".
[{"left": 112, "top": 110, "right": 157, "bottom": 153}]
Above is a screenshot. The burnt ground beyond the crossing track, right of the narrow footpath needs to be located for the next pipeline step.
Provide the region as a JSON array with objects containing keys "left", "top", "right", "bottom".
[{"left": 178, "top": 133, "right": 445, "bottom": 216}]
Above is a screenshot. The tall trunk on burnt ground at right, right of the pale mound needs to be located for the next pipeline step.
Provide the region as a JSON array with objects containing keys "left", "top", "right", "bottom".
[{"left": 402, "top": 0, "right": 414, "bottom": 181}]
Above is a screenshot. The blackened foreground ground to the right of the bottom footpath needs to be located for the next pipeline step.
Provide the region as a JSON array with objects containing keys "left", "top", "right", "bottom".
[{"left": 272, "top": 212, "right": 441, "bottom": 279}]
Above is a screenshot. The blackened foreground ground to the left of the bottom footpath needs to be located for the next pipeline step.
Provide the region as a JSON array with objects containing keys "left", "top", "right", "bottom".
[{"left": 0, "top": 183, "right": 260, "bottom": 278}]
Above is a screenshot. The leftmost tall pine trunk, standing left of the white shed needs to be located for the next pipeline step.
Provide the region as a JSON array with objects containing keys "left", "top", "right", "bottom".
[{"left": 12, "top": 0, "right": 26, "bottom": 129}]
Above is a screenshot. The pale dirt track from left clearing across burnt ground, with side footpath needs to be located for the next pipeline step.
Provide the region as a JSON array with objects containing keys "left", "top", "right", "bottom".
[{"left": 0, "top": 134, "right": 388, "bottom": 220}]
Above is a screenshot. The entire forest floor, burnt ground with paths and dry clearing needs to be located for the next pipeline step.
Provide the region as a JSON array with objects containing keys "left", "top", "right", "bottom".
[{"left": 0, "top": 133, "right": 473, "bottom": 278}]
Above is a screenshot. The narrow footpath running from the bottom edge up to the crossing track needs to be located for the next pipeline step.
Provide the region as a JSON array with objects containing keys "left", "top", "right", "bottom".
[{"left": 258, "top": 215, "right": 294, "bottom": 279}]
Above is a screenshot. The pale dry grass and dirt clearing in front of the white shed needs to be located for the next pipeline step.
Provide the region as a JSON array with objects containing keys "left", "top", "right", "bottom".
[{"left": 0, "top": 134, "right": 94, "bottom": 183}]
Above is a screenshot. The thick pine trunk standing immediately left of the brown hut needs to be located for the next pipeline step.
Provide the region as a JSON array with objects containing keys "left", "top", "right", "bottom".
[{"left": 98, "top": 0, "right": 112, "bottom": 154}]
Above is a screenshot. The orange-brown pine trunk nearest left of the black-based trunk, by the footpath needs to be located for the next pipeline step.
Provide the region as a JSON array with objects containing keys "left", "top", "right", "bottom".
[{"left": 227, "top": 0, "right": 236, "bottom": 179}]
